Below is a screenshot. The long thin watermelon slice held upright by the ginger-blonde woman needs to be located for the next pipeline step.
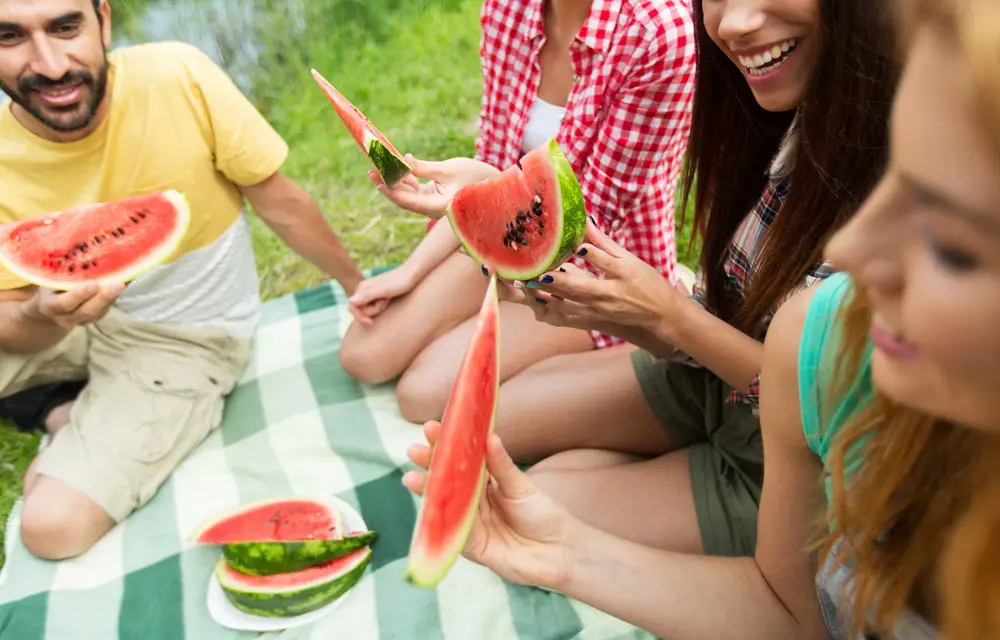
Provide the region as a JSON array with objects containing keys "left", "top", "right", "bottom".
[{"left": 403, "top": 276, "right": 500, "bottom": 588}]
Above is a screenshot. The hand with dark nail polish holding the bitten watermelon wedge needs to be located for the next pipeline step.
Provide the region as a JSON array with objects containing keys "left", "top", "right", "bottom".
[{"left": 503, "top": 221, "right": 687, "bottom": 344}]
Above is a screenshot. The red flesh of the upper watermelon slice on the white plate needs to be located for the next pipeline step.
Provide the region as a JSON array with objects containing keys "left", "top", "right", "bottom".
[{"left": 191, "top": 498, "right": 343, "bottom": 545}]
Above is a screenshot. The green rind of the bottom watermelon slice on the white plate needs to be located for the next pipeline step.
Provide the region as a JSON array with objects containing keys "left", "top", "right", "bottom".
[{"left": 215, "top": 549, "right": 372, "bottom": 618}]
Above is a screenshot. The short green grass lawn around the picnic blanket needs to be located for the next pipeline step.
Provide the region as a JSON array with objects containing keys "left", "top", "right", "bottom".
[{"left": 0, "top": 0, "right": 691, "bottom": 564}]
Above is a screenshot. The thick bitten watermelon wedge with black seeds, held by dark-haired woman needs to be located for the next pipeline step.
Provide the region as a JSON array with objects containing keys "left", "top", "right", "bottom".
[{"left": 448, "top": 139, "right": 587, "bottom": 280}]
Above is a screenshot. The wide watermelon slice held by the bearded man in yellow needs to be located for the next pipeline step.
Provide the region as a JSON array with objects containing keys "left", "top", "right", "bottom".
[{"left": 0, "top": 191, "right": 191, "bottom": 291}]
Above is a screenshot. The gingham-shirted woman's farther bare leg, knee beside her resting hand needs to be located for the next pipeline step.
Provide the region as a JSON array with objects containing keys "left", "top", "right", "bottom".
[{"left": 340, "top": 251, "right": 488, "bottom": 384}]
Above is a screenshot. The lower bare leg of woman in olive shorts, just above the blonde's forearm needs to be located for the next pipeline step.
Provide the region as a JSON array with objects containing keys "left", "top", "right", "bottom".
[{"left": 529, "top": 449, "right": 703, "bottom": 554}]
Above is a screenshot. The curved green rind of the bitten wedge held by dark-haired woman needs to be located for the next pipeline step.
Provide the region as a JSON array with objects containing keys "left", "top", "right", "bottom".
[{"left": 446, "top": 138, "right": 587, "bottom": 281}]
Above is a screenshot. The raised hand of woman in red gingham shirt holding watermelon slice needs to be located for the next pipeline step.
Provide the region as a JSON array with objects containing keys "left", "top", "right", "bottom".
[{"left": 368, "top": 153, "right": 500, "bottom": 219}]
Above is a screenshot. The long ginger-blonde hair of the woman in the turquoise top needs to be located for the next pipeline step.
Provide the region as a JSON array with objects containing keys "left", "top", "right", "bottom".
[{"left": 820, "top": 0, "right": 1000, "bottom": 640}]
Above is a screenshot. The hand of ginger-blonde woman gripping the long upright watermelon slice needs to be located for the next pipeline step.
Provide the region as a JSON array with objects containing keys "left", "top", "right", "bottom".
[{"left": 403, "top": 422, "right": 580, "bottom": 589}]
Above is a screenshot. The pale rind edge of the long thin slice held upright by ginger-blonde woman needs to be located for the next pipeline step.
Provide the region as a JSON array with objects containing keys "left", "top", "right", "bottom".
[{"left": 403, "top": 276, "right": 500, "bottom": 589}]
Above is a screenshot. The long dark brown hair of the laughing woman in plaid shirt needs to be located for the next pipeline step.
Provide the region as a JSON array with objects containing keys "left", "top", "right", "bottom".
[{"left": 680, "top": 0, "right": 899, "bottom": 335}]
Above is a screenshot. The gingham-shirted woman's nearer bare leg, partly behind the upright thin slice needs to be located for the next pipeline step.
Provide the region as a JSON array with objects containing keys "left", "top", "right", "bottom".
[{"left": 396, "top": 302, "right": 593, "bottom": 423}]
